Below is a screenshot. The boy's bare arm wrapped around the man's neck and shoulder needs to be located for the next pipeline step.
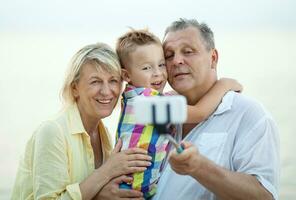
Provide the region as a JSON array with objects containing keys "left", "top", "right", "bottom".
[{"left": 185, "top": 78, "right": 243, "bottom": 123}]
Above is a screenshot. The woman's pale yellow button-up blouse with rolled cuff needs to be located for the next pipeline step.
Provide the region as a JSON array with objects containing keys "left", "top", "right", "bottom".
[{"left": 11, "top": 104, "right": 111, "bottom": 200}]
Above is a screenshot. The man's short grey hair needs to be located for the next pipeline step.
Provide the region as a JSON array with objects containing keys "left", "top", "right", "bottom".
[{"left": 164, "top": 18, "right": 215, "bottom": 50}]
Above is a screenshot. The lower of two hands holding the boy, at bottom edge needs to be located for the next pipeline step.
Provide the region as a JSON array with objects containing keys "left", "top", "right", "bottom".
[{"left": 94, "top": 175, "right": 144, "bottom": 200}]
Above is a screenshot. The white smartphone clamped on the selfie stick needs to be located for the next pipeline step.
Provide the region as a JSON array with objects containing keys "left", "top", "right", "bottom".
[{"left": 134, "top": 95, "right": 187, "bottom": 153}]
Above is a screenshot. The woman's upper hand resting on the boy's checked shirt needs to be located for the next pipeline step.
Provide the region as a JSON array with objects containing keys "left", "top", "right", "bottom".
[{"left": 100, "top": 139, "right": 152, "bottom": 179}]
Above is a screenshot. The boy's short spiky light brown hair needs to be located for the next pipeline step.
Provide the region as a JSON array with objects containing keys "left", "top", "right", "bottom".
[{"left": 116, "top": 29, "right": 162, "bottom": 68}]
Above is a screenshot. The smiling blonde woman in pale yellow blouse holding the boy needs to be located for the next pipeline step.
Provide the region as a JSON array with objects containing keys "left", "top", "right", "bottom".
[{"left": 12, "top": 43, "right": 151, "bottom": 200}]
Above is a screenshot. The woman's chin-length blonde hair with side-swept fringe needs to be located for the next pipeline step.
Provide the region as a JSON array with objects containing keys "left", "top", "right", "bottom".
[{"left": 61, "top": 43, "right": 121, "bottom": 105}]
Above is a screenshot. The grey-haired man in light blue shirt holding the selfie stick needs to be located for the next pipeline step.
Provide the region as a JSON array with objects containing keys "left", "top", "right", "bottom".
[{"left": 153, "top": 19, "right": 279, "bottom": 200}]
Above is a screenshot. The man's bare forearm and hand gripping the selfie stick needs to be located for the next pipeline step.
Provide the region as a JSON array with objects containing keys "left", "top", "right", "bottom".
[{"left": 169, "top": 142, "right": 273, "bottom": 200}]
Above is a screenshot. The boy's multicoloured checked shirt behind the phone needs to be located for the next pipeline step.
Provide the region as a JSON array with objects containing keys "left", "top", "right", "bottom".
[{"left": 116, "top": 85, "right": 168, "bottom": 198}]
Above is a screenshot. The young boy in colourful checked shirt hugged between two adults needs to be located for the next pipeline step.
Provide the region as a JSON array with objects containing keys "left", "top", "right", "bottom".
[{"left": 116, "top": 30, "right": 241, "bottom": 199}]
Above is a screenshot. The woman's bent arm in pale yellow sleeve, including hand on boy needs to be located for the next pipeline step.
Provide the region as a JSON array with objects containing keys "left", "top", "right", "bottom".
[{"left": 32, "top": 122, "right": 151, "bottom": 199}]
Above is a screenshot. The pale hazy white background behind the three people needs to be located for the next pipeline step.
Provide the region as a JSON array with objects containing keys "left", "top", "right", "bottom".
[{"left": 0, "top": 0, "right": 296, "bottom": 200}]
